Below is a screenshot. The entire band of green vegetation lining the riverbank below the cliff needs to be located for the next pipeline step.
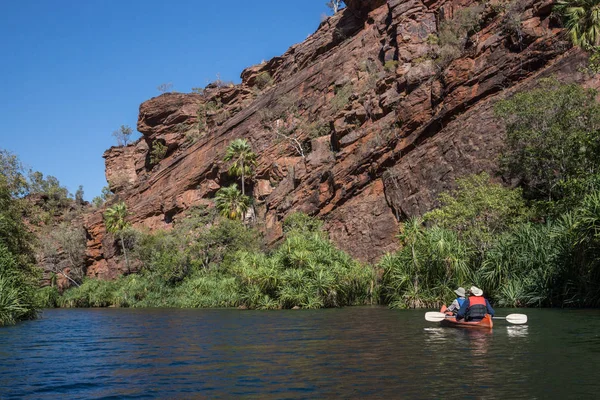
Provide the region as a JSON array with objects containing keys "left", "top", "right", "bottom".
[{"left": 8, "top": 79, "right": 600, "bottom": 316}]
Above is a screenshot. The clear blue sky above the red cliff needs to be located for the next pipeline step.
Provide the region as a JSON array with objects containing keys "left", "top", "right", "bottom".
[{"left": 0, "top": 0, "right": 336, "bottom": 200}]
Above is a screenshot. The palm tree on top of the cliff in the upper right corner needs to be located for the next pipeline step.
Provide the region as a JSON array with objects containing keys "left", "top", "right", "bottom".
[{"left": 555, "top": 0, "right": 600, "bottom": 50}]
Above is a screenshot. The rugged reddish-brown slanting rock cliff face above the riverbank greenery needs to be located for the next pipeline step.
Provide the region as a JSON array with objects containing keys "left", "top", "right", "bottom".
[{"left": 86, "top": 0, "right": 597, "bottom": 278}]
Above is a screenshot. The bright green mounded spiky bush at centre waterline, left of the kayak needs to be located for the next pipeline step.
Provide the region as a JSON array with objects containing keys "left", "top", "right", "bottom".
[{"left": 225, "top": 225, "right": 376, "bottom": 309}]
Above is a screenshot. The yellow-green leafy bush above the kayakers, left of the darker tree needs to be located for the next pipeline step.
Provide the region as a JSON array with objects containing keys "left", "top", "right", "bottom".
[{"left": 424, "top": 173, "right": 530, "bottom": 251}]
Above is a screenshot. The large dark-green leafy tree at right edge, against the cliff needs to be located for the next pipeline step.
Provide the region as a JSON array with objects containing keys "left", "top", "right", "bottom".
[{"left": 496, "top": 80, "right": 600, "bottom": 200}]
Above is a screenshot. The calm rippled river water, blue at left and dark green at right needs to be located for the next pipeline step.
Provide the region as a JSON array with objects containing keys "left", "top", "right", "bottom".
[{"left": 0, "top": 308, "right": 600, "bottom": 399}]
